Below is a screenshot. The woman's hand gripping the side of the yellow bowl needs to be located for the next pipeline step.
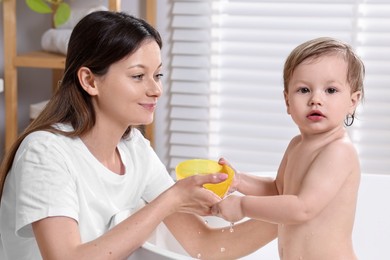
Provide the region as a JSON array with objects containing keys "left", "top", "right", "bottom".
[{"left": 170, "top": 173, "right": 228, "bottom": 216}]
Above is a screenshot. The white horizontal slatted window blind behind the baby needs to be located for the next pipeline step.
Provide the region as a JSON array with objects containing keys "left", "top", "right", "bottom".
[{"left": 168, "top": 0, "right": 390, "bottom": 173}]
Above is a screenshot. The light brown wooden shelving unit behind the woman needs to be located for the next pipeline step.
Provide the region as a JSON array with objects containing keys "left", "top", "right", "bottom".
[{"left": 3, "top": 0, "right": 156, "bottom": 151}]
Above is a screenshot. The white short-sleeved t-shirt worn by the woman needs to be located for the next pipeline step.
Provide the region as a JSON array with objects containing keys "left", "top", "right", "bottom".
[{"left": 0, "top": 125, "right": 173, "bottom": 260}]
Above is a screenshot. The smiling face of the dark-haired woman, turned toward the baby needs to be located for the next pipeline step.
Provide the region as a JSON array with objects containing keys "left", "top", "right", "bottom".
[{"left": 95, "top": 40, "right": 162, "bottom": 128}]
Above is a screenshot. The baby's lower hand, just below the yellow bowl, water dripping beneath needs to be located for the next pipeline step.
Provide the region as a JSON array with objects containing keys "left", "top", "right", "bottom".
[{"left": 211, "top": 195, "right": 245, "bottom": 223}]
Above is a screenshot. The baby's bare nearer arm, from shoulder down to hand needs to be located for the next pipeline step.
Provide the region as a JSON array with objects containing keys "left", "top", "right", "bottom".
[{"left": 214, "top": 142, "right": 359, "bottom": 224}]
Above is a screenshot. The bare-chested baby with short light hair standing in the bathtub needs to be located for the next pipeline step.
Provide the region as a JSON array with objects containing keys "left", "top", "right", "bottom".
[{"left": 213, "top": 38, "right": 365, "bottom": 260}]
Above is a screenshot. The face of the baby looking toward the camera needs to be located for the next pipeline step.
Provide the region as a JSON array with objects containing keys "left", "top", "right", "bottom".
[{"left": 284, "top": 54, "right": 361, "bottom": 133}]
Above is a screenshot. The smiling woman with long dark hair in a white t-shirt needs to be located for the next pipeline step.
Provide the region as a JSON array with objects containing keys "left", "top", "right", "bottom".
[{"left": 0, "top": 11, "right": 276, "bottom": 259}]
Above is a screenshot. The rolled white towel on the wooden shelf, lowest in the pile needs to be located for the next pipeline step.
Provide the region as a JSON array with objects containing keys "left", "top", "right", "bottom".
[{"left": 41, "top": 29, "right": 72, "bottom": 55}]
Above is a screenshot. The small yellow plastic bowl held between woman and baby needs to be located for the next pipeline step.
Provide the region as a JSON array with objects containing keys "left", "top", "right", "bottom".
[{"left": 176, "top": 159, "right": 234, "bottom": 198}]
